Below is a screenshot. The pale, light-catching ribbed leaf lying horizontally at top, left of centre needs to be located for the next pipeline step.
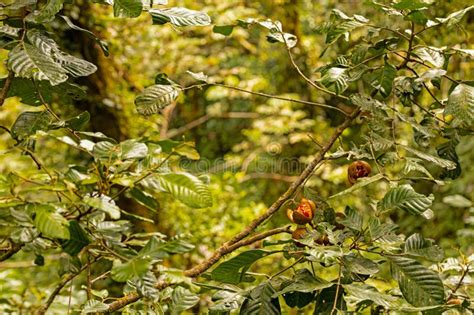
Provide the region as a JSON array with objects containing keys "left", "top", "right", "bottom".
[{"left": 148, "top": 7, "right": 211, "bottom": 26}]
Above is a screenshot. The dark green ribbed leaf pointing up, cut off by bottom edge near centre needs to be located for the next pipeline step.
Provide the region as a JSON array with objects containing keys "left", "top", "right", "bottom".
[{"left": 240, "top": 281, "right": 281, "bottom": 315}]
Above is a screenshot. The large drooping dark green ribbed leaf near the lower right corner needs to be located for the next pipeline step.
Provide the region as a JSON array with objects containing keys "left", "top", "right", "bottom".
[{"left": 387, "top": 255, "right": 444, "bottom": 306}]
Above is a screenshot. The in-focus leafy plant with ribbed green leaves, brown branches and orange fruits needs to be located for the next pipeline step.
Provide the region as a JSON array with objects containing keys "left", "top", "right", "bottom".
[{"left": 0, "top": 0, "right": 474, "bottom": 314}]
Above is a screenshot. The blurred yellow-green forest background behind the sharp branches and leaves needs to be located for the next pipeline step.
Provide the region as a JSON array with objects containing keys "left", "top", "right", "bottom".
[{"left": 0, "top": 0, "right": 474, "bottom": 314}]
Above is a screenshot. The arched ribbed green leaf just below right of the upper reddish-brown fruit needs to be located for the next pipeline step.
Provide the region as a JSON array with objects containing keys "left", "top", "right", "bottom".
[{"left": 377, "top": 184, "right": 434, "bottom": 215}]
